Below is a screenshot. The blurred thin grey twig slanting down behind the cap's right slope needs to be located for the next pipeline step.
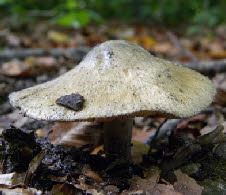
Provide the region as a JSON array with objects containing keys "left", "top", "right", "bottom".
[{"left": 166, "top": 31, "right": 198, "bottom": 62}]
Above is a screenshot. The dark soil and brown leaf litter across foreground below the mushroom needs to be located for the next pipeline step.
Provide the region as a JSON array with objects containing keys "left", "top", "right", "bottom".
[{"left": 0, "top": 122, "right": 225, "bottom": 194}]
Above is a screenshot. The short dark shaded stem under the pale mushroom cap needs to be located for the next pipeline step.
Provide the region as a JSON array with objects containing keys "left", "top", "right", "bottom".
[{"left": 103, "top": 119, "right": 133, "bottom": 161}]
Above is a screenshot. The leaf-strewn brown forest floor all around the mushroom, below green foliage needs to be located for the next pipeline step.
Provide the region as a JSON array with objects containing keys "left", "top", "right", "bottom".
[{"left": 0, "top": 23, "right": 226, "bottom": 194}]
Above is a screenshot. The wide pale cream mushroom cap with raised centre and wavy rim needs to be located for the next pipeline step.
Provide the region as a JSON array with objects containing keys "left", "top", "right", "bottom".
[{"left": 9, "top": 40, "right": 216, "bottom": 121}]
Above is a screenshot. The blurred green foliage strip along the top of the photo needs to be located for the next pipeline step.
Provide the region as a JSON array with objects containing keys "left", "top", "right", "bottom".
[{"left": 0, "top": 0, "right": 226, "bottom": 32}]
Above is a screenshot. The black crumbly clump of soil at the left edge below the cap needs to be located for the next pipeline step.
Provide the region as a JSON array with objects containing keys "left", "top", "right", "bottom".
[{"left": 0, "top": 126, "right": 42, "bottom": 173}]
